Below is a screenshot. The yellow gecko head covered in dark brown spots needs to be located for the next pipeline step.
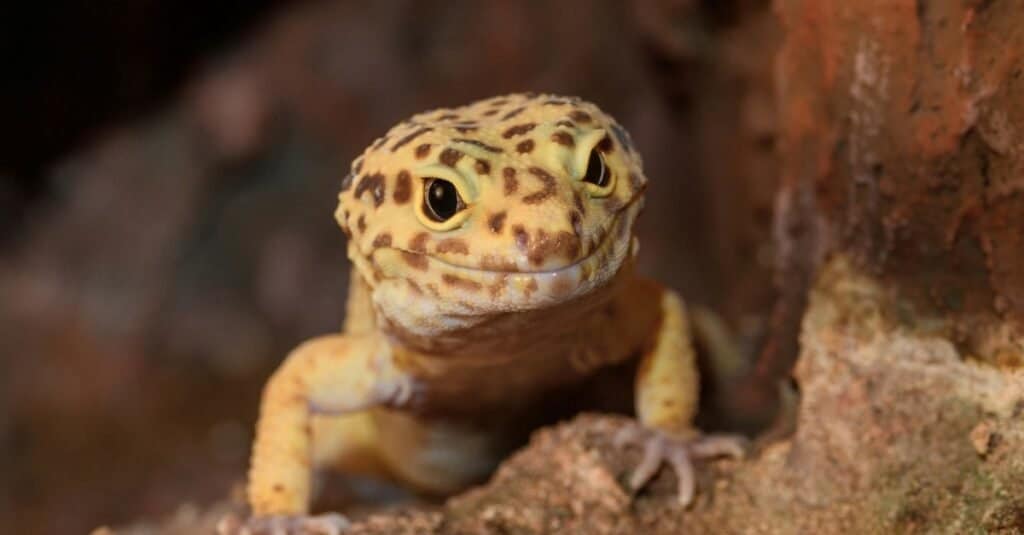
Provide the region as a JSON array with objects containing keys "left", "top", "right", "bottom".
[{"left": 335, "top": 94, "right": 647, "bottom": 336}]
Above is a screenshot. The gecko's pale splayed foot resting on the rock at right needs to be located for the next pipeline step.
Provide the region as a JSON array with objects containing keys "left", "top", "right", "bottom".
[{"left": 614, "top": 423, "right": 748, "bottom": 507}]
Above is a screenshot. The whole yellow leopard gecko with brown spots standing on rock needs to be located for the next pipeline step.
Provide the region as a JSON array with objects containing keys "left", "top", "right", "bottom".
[{"left": 243, "top": 94, "right": 734, "bottom": 518}]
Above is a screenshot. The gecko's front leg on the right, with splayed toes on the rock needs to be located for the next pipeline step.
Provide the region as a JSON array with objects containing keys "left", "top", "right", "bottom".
[{"left": 615, "top": 282, "right": 746, "bottom": 506}]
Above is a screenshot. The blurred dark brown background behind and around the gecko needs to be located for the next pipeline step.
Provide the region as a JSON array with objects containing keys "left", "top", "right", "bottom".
[{"left": 0, "top": 0, "right": 779, "bottom": 533}]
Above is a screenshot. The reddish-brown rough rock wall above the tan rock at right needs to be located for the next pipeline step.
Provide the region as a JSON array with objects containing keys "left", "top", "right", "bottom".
[{"left": 776, "top": 0, "right": 1024, "bottom": 365}]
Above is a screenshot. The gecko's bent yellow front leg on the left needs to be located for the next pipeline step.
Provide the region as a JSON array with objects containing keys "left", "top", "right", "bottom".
[{"left": 228, "top": 332, "right": 413, "bottom": 533}]
